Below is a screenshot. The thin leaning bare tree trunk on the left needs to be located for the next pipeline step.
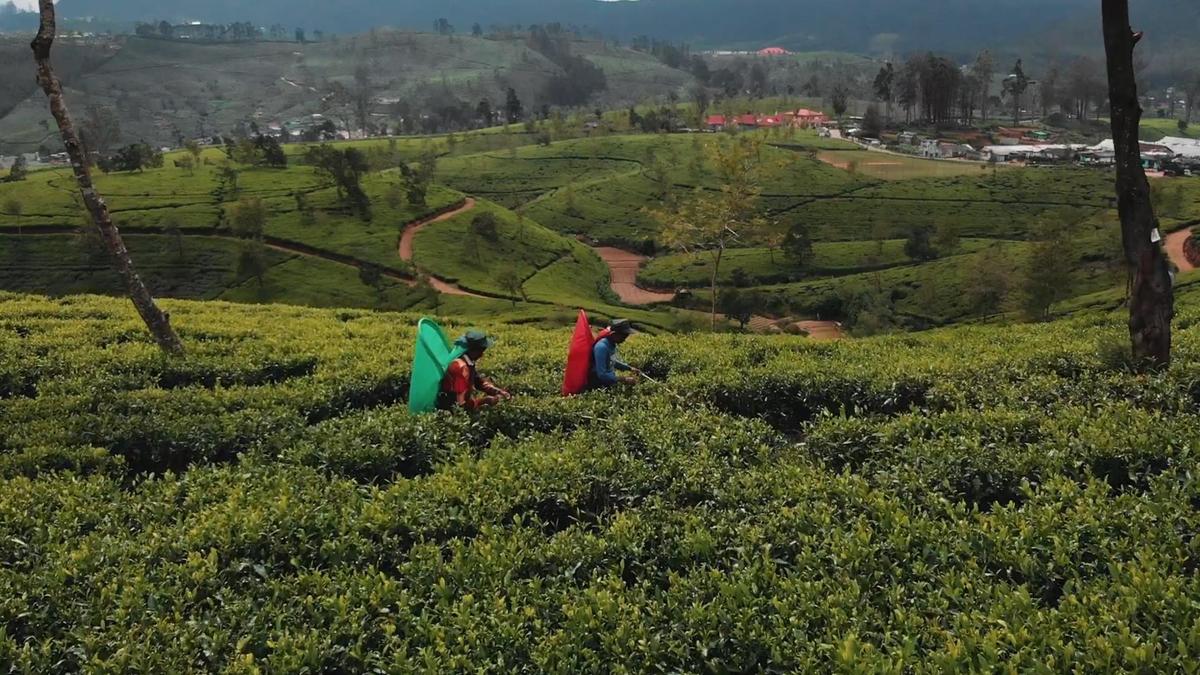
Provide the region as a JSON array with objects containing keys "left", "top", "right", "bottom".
[{"left": 30, "top": 0, "right": 184, "bottom": 354}]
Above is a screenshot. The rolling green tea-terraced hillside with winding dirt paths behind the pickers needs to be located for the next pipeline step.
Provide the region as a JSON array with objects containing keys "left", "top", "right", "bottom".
[{"left": 0, "top": 125, "right": 1200, "bottom": 329}]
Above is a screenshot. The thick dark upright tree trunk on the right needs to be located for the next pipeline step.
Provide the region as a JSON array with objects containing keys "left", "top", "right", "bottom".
[{"left": 1102, "top": 0, "right": 1175, "bottom": 368}]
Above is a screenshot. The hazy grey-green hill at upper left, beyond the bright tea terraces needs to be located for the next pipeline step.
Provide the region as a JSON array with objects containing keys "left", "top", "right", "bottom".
[{"left": 0, "top": 30, "right": 694, "bottom": 153}]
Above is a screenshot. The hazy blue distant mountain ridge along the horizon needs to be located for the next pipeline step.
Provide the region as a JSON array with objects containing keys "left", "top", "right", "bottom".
[{"left": 18, "top": 0, "right": 1200, "bottom": 59}]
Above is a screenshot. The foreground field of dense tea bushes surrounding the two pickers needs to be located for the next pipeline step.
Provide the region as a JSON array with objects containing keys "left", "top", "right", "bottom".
[{"left": 0, "top": 290, "right": 1200, "bottom": 673}]
